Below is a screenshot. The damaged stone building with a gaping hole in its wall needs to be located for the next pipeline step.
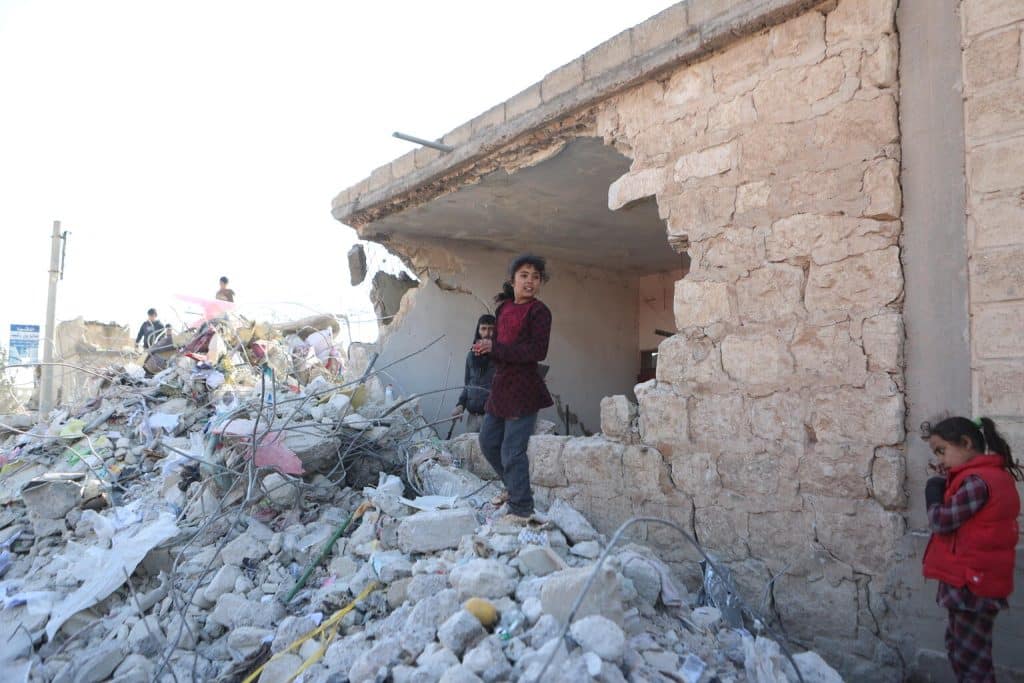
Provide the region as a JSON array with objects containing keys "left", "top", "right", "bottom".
[{"left": 333, "top": 0, "right": 1024, "bottom": 680}]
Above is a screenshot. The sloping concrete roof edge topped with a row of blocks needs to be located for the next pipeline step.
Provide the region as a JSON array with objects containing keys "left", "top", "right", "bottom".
[{"left": 332, "top": 0, "right": 822, "bottom": 233}]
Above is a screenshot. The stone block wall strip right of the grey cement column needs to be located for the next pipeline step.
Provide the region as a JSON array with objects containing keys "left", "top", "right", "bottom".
[{"left": 961, "top": 0, "right": 1024, "bottom": 457}]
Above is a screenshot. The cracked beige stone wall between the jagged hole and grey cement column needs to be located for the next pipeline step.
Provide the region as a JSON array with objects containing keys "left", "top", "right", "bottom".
[{"left": 593, "top": 0, "right": 905, "bottom": 680}]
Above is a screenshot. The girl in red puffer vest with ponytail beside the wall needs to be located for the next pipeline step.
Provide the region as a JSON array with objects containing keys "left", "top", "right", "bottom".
[{"left": 921, "top": 418, "right": 1024, "bottom": 681}]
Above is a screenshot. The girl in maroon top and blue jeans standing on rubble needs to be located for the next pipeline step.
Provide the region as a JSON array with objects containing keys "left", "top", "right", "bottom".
[{"left": 473, "top": 254, "right": 554, "bottom": 524}]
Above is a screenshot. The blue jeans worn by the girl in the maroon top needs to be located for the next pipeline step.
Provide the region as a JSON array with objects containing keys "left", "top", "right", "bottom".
[{"left": 480, "top": 413, "right": 537, "bottom": 517}]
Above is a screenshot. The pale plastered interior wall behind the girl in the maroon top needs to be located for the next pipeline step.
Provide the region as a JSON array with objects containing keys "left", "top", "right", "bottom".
[{"left": 368, "top": 245, "right": 639, "bottom": 434}]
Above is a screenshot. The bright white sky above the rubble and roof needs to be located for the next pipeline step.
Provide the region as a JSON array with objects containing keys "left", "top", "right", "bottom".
[{"left": 0, "top": 0, "right": 670, "bottom": 345}]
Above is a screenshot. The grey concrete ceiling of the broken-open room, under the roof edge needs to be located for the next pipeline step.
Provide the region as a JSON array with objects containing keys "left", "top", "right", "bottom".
[{"left": 372, "top": 137, "right": 681, "bottom": 272}]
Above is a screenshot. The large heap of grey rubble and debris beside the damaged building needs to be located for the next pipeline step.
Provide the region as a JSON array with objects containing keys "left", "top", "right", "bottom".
[{"left": 0, "top": 313, "right": 842, "bottom": 683}]
